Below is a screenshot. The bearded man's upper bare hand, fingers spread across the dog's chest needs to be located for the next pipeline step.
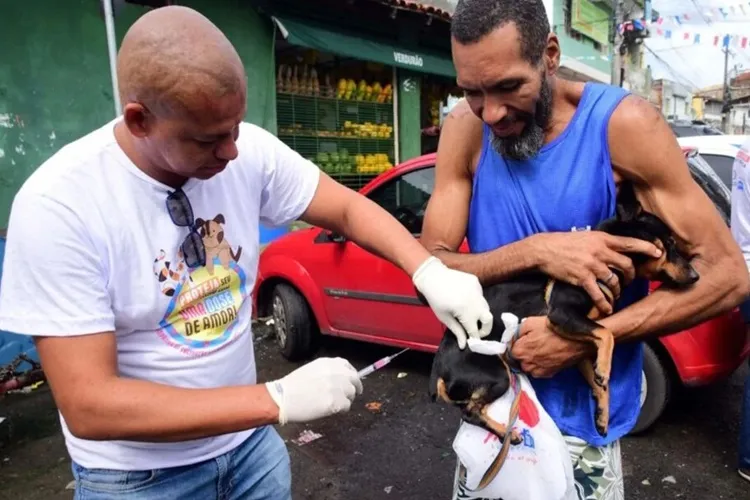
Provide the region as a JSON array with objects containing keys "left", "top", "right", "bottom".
[{"left": 533, "top": 231, "right": 661, "bottom": 314}]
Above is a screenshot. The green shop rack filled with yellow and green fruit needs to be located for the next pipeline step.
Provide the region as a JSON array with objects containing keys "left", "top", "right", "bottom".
[{"left": 276, "top": 92, "right": 396, "bottom": 189}]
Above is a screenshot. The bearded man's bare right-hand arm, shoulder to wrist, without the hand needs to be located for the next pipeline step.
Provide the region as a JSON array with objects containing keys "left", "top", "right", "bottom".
[{"left": 601, "top": 97, "right": 750, "bottom": 341}]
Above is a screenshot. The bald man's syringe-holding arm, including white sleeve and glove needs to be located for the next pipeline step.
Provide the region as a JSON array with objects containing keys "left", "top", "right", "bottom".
[{"left": 0, "top": 189, "right": 361, "bottom": 441}]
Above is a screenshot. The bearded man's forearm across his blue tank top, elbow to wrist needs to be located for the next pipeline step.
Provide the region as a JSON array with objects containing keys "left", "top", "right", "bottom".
[{"left": 432, "top": 236, "right": 539, "bottom": 285}]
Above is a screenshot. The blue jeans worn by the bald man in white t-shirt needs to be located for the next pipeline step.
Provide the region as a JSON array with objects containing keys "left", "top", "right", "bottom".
[{"left": 73, "top": 426, "right": 292, "bottom": 500}]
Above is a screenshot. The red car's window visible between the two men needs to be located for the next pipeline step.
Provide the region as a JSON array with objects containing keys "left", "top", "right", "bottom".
[{"left": 367, "top": 166, "right": 435, "bottom": 236}]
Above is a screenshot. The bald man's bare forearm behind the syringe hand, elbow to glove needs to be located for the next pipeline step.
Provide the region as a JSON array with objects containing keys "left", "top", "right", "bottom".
[{"left": 58, "top": 377, "right": 279, "bottom": 442}]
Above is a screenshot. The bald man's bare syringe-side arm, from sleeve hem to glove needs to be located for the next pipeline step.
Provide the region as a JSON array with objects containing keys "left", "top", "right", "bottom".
[{"left": 36, "top": 332, "right": 279, "bottom": 442}]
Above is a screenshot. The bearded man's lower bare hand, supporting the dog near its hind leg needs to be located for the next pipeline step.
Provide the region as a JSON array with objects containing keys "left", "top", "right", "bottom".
[{"left": 510, "top": 316, "right": 593, "bottom": 378}]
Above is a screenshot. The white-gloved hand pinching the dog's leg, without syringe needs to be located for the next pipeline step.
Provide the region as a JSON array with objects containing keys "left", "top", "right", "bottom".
[{"left": 412, "top": 256, "right": 493, "bottom": 349}]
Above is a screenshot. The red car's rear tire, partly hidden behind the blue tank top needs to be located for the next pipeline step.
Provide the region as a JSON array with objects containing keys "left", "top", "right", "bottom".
[{"left": 630, "top": 344, "right": 671, "bottom": 435}]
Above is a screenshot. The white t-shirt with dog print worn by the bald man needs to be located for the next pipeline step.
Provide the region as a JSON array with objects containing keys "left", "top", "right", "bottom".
[{"left": 0, "top": 121, "right": 320, "bottom": 470}]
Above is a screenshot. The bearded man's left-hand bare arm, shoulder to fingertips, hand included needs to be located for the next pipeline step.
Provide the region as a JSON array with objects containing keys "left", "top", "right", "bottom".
[{"left": 422, "top": 101, "right": 658, "bottom": 314}]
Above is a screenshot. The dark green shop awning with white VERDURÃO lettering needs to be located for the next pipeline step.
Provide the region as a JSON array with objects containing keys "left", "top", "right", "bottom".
[{"left": 272, "top": 17, "right": 456, "bottom": 78}]
